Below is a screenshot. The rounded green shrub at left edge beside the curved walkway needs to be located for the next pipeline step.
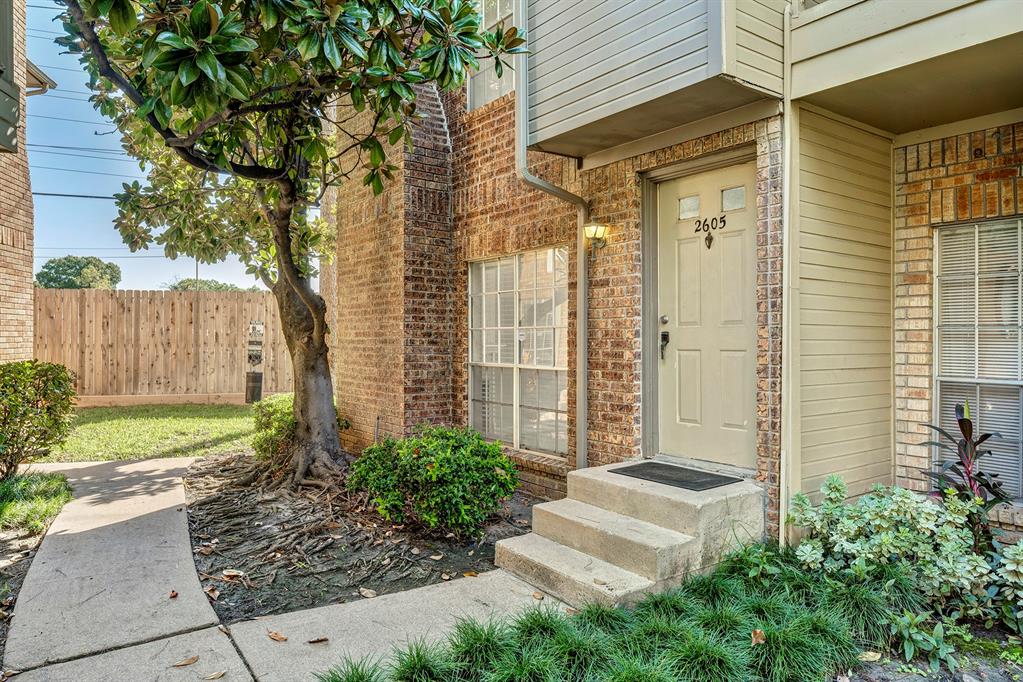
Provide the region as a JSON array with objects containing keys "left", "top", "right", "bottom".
[{"left": 0, "top": 360, "right": 75, "bottom": 481}]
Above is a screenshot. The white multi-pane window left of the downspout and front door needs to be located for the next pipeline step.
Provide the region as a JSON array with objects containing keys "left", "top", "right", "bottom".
[{"left": 469, "top": 247, "right": 568, "bottom": 454}]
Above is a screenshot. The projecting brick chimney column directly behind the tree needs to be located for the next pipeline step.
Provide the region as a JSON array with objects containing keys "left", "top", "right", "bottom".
[{"left": 320, "top": 87, "right": 452, "bottom": 453}]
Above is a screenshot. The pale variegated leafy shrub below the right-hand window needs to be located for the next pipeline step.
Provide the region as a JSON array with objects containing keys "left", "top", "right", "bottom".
[{"left": 790, "top": 472, "right": 1023, "bottom": 672}]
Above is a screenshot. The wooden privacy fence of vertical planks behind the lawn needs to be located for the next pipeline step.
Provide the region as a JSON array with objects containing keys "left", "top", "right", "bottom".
[{"left": 34, "top": 288, "right": 292, "bottom": 406}]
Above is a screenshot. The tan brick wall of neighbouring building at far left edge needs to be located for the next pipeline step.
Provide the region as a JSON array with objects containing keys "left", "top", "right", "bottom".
[{"left": 0, "top": 2, "right": 33, "bottom": 362}]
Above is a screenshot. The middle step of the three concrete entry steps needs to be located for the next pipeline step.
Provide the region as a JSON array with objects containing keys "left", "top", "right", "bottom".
[{"left": 533, "top": 499, "right": 699, "bottom": 582}]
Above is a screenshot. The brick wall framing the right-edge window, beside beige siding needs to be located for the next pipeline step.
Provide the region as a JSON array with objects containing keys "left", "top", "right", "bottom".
[{"left": 894, "top": 122, "right": 1023, "bottom": 530}]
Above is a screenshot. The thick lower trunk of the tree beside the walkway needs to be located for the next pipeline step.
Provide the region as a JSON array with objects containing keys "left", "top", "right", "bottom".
[{"left": 273, "top": 278, "right": 345, "bottom": 487}]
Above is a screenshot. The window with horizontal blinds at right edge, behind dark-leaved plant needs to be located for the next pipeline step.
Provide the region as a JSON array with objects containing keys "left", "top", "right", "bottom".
[{"left": 935, "top": 220, "right": 1023, "bottom": 498}]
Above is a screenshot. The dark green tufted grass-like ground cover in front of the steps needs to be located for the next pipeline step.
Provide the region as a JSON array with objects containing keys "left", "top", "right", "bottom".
[{"left": 318, "top": 545, "right": 894, "bottom": 682}]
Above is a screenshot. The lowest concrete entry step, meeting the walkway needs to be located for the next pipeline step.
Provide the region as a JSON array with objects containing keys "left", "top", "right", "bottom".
[{"left": 494, "top": 533, "right": 656, "bottom": 607}]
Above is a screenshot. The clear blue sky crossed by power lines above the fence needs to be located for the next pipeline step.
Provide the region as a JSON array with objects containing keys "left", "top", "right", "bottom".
[{"left": 28, "top": 0, "right": 262, "bottom": 289}]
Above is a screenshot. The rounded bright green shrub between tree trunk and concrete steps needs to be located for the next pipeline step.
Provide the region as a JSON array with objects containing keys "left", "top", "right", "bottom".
[{"left": 348, "top": 426, "right": 519, "bottom": 536}]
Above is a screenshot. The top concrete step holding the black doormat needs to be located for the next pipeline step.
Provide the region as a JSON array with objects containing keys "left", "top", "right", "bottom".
[{"left": 568, "top": 463, "right": 764, "bottom": 548}]
